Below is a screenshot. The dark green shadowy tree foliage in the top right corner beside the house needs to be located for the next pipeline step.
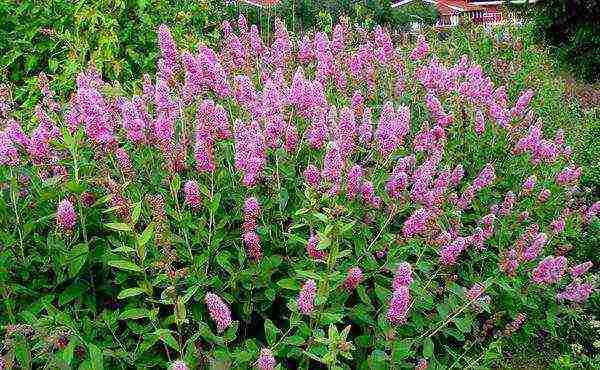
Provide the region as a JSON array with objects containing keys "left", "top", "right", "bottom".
[{"left": 531, "top": 0, "right": 600, "bottom": 82}]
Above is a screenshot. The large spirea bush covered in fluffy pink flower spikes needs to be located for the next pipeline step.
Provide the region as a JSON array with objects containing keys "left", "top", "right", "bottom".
[{"left": 0, "top": 17, "right": 600, "bottom": 370}]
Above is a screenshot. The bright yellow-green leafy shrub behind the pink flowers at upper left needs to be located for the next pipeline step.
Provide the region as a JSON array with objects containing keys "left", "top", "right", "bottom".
[{"left": 0, "top": 0, "right": 229, "bottom": 103}]
